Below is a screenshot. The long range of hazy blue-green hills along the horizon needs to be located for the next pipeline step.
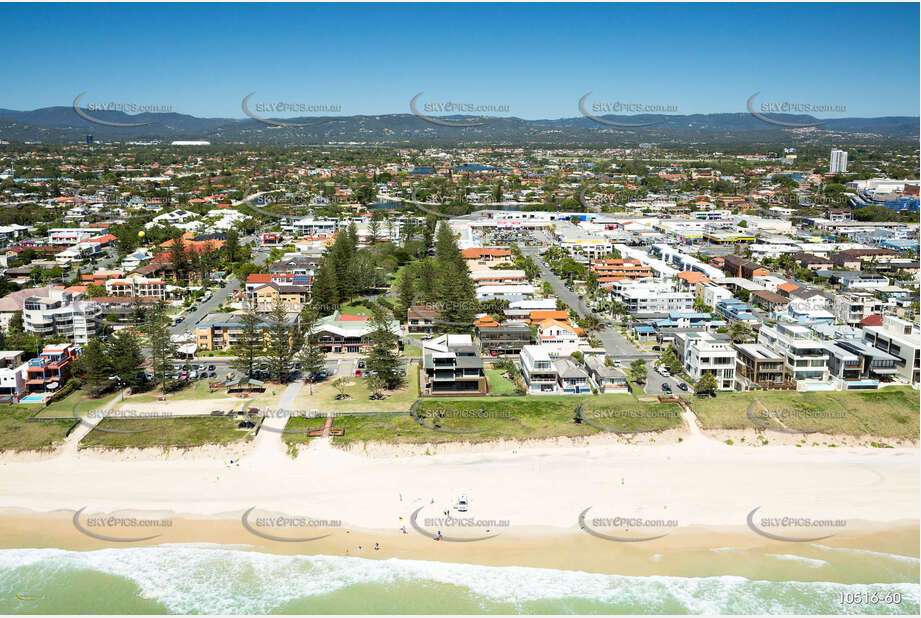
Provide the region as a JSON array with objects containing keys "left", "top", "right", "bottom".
[{"left": 0, "top": 107, "right": 919, "bottom": 145}]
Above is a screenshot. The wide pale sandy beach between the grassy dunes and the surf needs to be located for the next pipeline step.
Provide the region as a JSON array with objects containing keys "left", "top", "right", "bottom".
[{"left": 0, "top": 432, "right": 919, "bottom": 574}]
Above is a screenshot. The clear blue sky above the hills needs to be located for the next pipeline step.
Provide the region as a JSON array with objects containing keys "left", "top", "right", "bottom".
[{"left": 0, "top": 2, "right": 919, "bottom": 119}]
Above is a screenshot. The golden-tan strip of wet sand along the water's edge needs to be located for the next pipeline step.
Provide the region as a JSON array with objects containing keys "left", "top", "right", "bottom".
[{"left": 0, "top": 509, "right": 919, "bottom": 581}]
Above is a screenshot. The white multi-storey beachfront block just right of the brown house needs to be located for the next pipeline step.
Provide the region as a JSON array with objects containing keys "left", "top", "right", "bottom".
[{"left": 758, "top": 322, "right": 829, "bottom": 382}]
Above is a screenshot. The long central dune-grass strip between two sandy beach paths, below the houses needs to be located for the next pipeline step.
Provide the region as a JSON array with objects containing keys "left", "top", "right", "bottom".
[{"left": 285, "top": 395, "right": 681, "bottom": 445}]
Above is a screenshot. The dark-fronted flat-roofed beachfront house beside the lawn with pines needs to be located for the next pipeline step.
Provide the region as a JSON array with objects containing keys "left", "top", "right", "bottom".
[{"left": 420, "top": 335, "right": 489, "bottom": 397}]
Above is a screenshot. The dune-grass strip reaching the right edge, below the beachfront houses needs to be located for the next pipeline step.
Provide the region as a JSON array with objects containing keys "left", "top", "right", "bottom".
[{"left": 691, "top": 386, "right": 919, "bottom": 440}]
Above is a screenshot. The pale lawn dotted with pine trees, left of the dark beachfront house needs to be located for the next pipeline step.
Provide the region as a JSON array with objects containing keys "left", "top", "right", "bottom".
[{"left": 294, "top": 365, "right": 419, "bottom": 412}]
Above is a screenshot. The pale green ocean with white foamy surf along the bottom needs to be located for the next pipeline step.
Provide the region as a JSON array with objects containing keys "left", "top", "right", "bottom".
[{"left": 0, "top": 544, "right": 919, "bottom": 615}]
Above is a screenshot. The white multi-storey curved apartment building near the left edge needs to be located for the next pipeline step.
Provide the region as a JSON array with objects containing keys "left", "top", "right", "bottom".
[{"left": 22, "top": 289, "right": 102, "bottom": 344}]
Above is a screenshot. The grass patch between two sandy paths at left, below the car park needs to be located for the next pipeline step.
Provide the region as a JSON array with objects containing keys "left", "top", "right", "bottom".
[{"left": 80, "top": 417, "right": 252, "bottom": 448}]
